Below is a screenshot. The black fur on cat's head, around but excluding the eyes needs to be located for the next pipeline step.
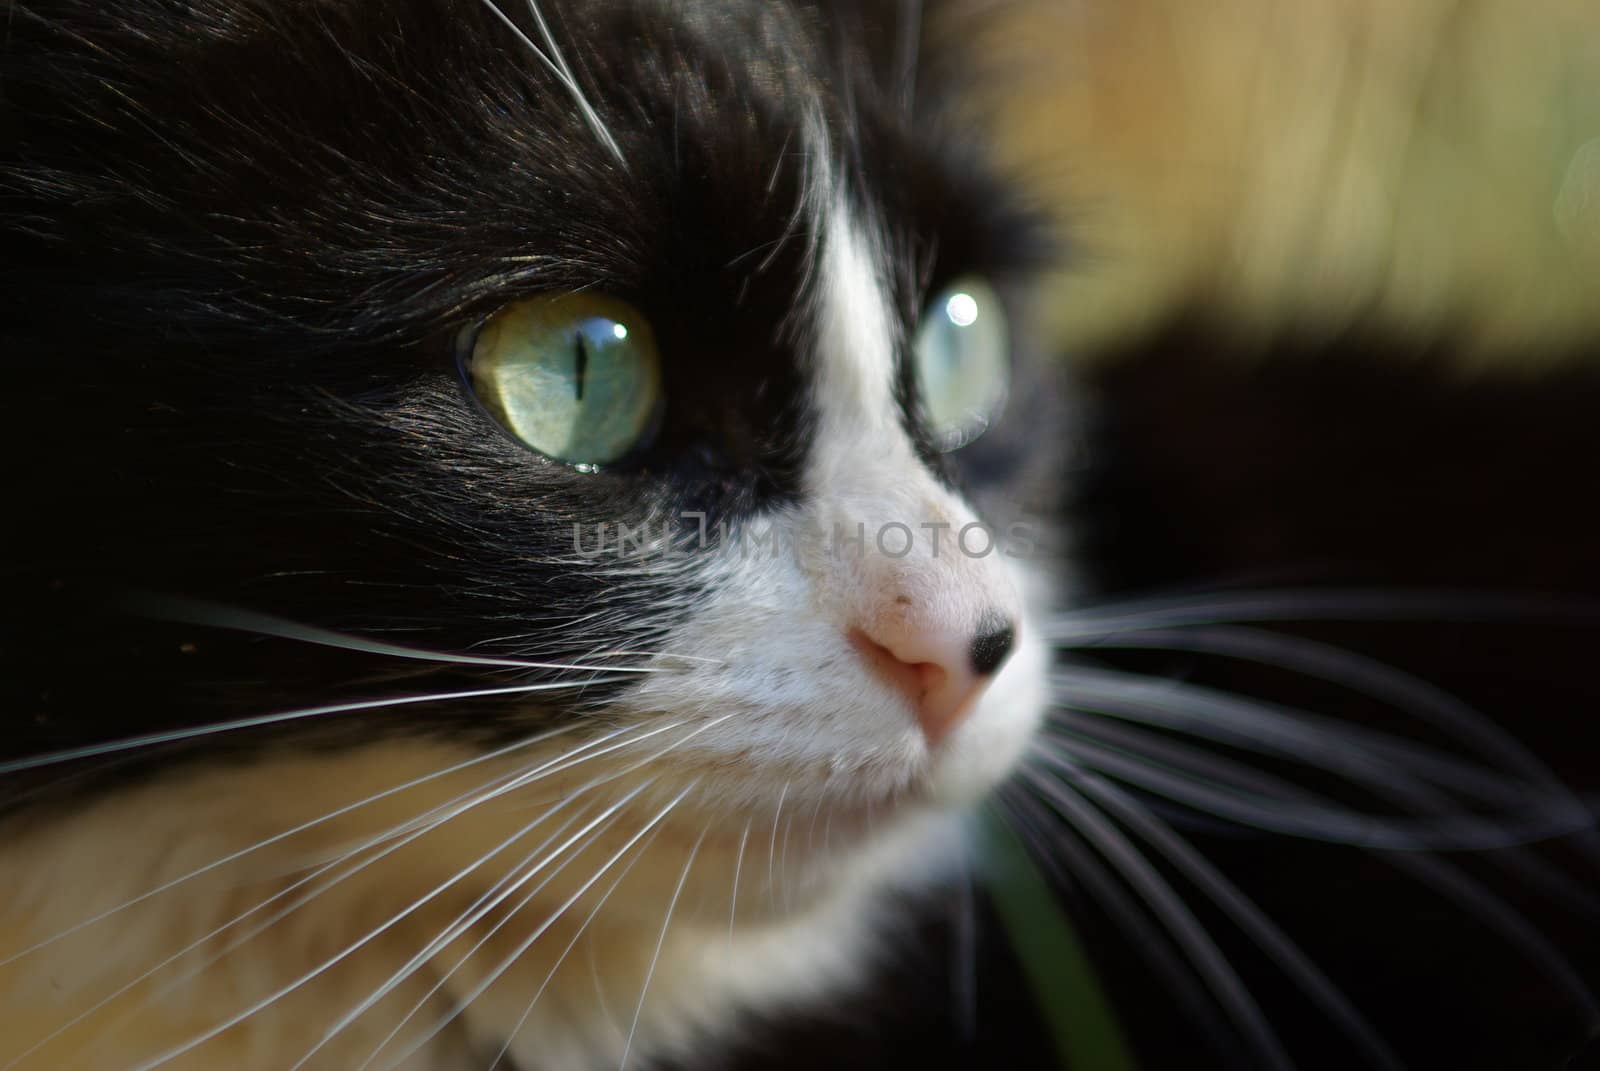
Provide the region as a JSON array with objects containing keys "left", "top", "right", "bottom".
[{"left": 0, "top": 0, "right": 1043, "bottom": 797}]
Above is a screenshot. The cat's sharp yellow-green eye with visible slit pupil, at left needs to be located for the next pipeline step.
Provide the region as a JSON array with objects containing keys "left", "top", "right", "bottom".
[{"left": 462, "top": 293, "right": 661, "bottom": 467}]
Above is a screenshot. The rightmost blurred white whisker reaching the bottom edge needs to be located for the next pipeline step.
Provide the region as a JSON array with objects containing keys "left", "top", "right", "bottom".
[{"left": 1074, "top": 772, "right": 1403, "bottom": 1071}]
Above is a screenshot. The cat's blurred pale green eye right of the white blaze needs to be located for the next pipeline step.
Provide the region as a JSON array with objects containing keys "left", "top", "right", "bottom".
[{"left": 915, "top": 275, "right": 1011, "bottom": 450}]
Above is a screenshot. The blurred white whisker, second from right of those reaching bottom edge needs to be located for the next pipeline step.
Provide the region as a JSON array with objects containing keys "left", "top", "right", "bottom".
[{"left": 1022, "top": 768, "right": 1294, "bottom": 1071}]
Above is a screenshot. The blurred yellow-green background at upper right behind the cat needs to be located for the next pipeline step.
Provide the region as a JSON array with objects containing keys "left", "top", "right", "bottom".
[{"left": 963, "top": 0, "right": 1600, "bottom": 368}]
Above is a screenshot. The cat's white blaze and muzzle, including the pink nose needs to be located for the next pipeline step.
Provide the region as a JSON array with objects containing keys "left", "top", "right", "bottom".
[{"left": 630, "top": 185, "right": 1046, "bottom": 807}]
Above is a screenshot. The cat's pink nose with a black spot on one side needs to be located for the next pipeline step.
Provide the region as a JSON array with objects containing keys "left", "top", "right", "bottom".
[{"left": 850, "top": 621, "right": 1016, "bottom": 748}]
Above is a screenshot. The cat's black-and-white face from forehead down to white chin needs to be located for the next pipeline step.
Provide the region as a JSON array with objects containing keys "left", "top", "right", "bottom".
[{"left": 6, "top": 3, "right": 1040, "bottom": 826}]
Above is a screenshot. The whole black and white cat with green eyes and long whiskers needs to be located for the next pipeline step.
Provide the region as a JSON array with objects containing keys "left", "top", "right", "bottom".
[{"left": 0, "top": 0, "right": 1600, "bottom": 1071}]
